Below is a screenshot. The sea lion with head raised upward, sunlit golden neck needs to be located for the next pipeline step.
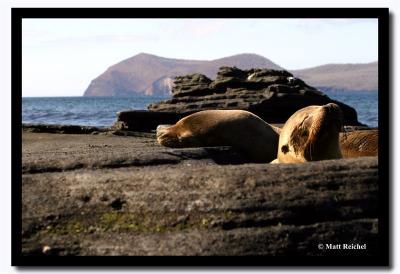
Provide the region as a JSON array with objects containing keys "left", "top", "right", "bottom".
[{"left": 272, "top": 103, "right": 343, "bottom": 163}]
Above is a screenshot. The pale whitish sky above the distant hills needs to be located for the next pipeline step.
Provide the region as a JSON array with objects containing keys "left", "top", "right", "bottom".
[{"left": 22, "top": 19, "right": 378, "bottom": 96}]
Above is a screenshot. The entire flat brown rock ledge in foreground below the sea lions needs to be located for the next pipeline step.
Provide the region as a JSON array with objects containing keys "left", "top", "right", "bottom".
[{"left": 21, "top": 130, "right": 378, "bottom": 256}]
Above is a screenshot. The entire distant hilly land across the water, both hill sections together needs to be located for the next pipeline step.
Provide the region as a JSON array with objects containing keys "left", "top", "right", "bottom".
[{"left": 84, "top": 53, "right": 378, "bottom": 96}]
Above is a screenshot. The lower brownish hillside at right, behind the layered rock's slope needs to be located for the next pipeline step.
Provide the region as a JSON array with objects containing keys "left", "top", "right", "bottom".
[{"left": 291, "top": 62, "right": 378, "bottom": 91}]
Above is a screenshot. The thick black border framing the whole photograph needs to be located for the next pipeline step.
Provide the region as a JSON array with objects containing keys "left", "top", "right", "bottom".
[{"left": 11, "top": 8, "right": 390, "bottom": 269}]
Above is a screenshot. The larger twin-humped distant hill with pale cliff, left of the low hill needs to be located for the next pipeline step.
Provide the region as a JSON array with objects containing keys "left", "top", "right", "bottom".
[{"left": 84, "top": 53, "right": 282, "bottom": 96}]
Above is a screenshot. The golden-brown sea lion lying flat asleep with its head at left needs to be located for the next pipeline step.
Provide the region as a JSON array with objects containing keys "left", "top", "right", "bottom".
[{"left": 157, "top": 110, "right": 279, "bottom": 162}]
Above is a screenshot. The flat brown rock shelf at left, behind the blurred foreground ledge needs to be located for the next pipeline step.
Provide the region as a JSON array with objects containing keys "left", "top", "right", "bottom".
[{"left": 22, "top": 132, "right": 246, "bottom": 173}]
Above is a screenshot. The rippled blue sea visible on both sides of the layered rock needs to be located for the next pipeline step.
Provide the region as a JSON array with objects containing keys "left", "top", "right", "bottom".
[{"left": 22, "top": 91, "right": 378, "bottom": 127}]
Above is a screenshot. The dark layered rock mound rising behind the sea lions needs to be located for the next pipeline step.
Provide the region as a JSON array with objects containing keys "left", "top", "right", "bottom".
[{"left": 146, "top": 67, "right": 360, "bottom": 125}]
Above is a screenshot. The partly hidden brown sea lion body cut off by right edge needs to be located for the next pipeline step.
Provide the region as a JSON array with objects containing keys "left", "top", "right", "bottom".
[{"left": 340, "top": 129, "right": 378, "bottom": 158}]
